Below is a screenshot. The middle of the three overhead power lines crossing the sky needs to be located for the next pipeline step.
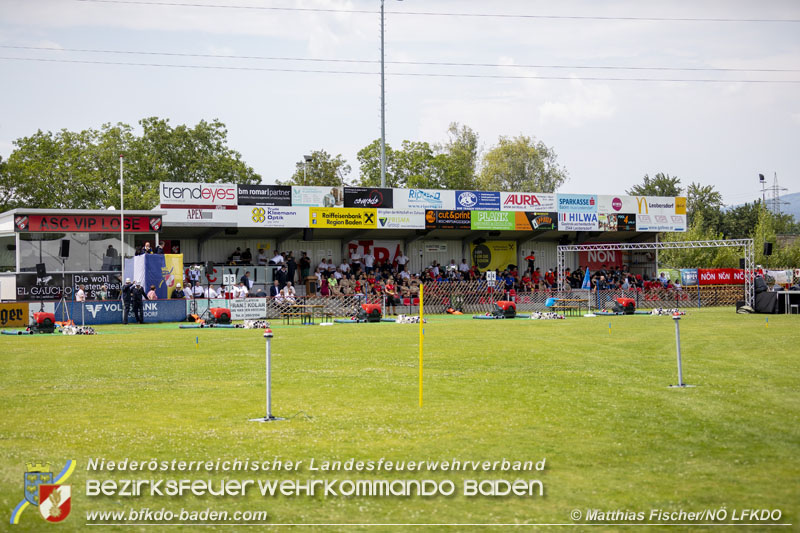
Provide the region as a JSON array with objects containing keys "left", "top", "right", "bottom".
[{"left": 0, "top": 45, "right": 800, "bottom": 73}]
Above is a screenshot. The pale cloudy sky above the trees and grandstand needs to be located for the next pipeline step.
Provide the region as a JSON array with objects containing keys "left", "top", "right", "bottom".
[{"left": 0, "top": 0, "right": 800, "bottom": 204}]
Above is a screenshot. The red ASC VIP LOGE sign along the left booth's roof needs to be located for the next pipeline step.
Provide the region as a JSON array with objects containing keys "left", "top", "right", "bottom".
[{"left": 14, "top": 215, "right": 161, "bottom": 233}]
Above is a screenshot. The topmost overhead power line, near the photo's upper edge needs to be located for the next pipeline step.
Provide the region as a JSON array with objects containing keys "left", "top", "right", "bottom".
[{"left": 75, "top": 0, "right": 800, "bottom": 23}]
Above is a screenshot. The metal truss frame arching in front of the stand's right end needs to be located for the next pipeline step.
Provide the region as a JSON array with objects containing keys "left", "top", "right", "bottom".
[{"left": 557, "top": 239, "right": 755, "bottom": 306}]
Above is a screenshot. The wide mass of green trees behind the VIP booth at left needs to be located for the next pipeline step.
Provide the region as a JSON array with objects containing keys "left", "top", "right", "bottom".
[{"left": 0, "top": 117, "right": 260, "bottom": 210}]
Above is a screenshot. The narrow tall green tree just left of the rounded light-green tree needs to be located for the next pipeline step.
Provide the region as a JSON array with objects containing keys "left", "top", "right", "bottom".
[{"left": 434, "top": 122, "right": 480, "bottom": 190}]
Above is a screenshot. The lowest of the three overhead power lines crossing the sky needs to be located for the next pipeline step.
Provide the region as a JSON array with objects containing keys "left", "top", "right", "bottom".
[{"left": 0, "top": 56, "right": 800, "bottom": 84}]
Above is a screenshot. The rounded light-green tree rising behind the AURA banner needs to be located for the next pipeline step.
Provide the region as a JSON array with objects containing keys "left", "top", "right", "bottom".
[{"left": 478, "top": 135, "right": 568, "bottom": 192}]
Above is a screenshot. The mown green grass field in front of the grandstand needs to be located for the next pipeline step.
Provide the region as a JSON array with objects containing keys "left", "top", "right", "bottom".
[{"left": 0, "top": 308, "right": 800, "bottom": 531}]
